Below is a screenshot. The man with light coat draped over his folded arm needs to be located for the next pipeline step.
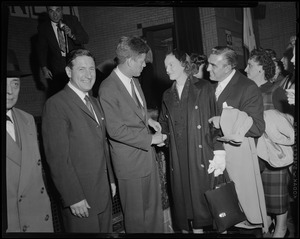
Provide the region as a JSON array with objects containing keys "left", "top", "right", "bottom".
[{"left": 207, "top": 46, "right": 266, "bottom": 236}]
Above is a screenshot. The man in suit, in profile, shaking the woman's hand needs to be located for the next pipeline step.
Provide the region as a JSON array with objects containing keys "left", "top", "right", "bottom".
[{"left": 98, "top": 37, "right": 167, "bottom": 233}]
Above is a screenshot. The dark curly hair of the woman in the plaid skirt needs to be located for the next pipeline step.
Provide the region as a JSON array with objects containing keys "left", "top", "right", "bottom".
[{"left": 249, "top": 48, "right": 275, "bottom": 81}]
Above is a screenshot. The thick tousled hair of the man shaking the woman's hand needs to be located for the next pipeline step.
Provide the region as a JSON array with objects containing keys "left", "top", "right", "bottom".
[{"left": 116, "top": 36, "right": 150, "bottom": 63}]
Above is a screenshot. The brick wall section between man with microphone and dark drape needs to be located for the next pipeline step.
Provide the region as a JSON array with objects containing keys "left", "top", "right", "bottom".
[{"left": 79, "top": 6, "right": 173, "bottom": 65}]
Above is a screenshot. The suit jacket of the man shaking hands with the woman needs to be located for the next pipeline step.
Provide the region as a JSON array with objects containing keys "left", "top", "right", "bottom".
[{"left": 98, "top": 71, "right": 155, "bottom": 179}]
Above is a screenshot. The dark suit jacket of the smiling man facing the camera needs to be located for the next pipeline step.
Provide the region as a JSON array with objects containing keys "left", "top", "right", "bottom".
[{"left": 42, "top": 85, "right": 113, "bottom": 215}]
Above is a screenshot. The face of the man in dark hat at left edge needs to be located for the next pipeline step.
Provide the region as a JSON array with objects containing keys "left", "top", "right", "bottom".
[{"left": 6, "top": 77, "right": 20, "bottom": 110}]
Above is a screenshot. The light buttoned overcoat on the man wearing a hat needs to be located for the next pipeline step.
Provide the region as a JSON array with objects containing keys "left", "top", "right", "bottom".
[{"left": 6, "top": 108, "right": 53, "bottom": 232}]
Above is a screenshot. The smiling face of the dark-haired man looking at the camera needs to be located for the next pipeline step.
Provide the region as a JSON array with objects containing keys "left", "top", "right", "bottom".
[{"left": 66, "top": 56, "right": 96, "bottom": 93}]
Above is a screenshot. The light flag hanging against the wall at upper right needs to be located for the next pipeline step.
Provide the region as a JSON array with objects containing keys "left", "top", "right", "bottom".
[{"left": 243, "top": 8, "right": 256, "bottom": 53}]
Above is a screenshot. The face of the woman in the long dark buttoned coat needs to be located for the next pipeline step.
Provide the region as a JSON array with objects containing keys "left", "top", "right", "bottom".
[{"left": 165, "top": 54, "right": 186, "bottom": 80}]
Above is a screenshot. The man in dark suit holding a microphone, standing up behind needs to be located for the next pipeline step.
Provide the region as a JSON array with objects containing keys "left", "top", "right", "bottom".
[{"left": 37, "top": 6, "right": 89, "bottom": 96}]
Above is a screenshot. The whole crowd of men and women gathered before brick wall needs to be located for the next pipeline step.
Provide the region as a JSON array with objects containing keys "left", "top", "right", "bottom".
[{"left": 6, "top": 6, "right": 296, "bottom": 237}]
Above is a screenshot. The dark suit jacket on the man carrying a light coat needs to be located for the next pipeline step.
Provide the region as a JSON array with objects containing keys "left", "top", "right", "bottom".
[{"left": 217, "top": 70, "right": 265, "bottom": 138}]
